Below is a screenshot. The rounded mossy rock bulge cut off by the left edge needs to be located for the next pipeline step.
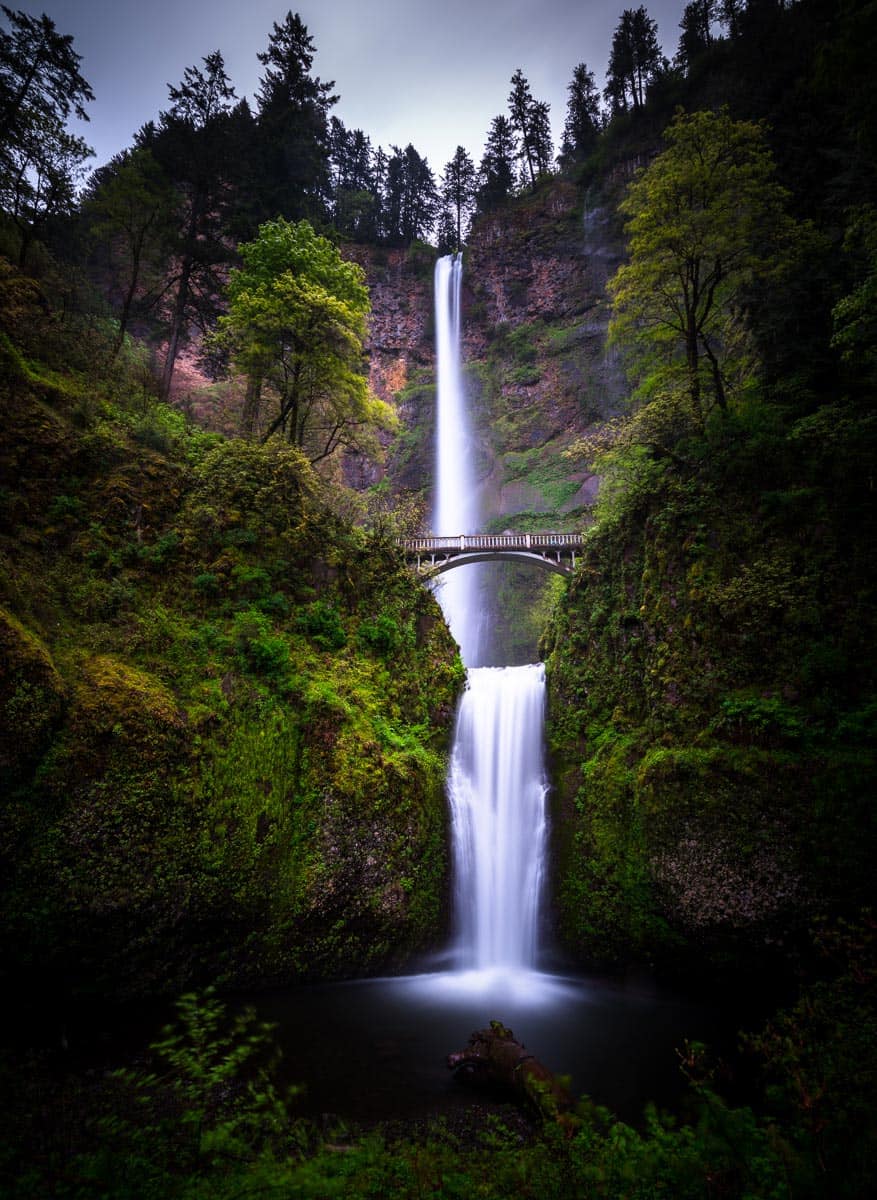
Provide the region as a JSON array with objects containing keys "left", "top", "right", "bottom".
[{"left": 0, "top": 608, "right": 65, "bottom": 785}]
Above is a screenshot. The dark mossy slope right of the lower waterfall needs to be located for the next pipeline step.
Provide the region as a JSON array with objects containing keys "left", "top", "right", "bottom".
[{"left": 547, "top": 402, "right": 877, "bottom": 962}]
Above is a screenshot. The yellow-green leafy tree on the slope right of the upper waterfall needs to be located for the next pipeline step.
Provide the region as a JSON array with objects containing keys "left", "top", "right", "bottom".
[{"left": 609, "top": 109, "right": 795, "bottom": 425}]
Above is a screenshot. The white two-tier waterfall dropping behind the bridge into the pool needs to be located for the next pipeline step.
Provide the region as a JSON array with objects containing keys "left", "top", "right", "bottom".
[{"left": 433, "top": 256, "right": 547, "bottom": 972}]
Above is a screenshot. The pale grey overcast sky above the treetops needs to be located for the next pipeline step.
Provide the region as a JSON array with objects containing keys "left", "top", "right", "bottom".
[{"left": 7, "top": 0, "right": 685, "bottom": 175}]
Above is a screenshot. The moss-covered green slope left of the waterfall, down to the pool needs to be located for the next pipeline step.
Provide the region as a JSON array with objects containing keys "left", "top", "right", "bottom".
[{"left": 0, "top": 348, "right": 462, "bottom": 994}]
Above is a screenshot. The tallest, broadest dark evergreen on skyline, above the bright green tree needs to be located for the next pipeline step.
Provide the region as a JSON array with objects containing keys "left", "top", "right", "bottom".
[{"left": 257, "top": 12, "right": 338, "bottom": 218}]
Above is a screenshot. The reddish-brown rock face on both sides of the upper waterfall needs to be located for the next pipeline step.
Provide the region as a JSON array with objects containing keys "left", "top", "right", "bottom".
[{"left": 346, "top": 180, "right": 624, "bottom": 529}]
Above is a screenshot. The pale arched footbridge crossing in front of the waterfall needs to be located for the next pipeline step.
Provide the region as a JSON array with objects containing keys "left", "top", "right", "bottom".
[{"left": 400, "top": 533, "right": 582, "bottom": 577}]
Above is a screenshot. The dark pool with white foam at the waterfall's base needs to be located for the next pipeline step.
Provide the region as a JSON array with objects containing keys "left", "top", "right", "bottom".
[{"left": 247, "top": 971, "right": 734, "bottom": 1121}]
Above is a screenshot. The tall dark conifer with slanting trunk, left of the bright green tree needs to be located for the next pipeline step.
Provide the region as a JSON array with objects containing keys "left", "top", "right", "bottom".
[{"left": 148, "top": 50, "right": 235, "bottom": 398}]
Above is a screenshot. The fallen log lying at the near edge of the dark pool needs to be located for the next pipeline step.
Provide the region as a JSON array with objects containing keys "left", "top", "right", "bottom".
[{"left": 447, "top": 1021, "right": 572, "bottom": 1120}]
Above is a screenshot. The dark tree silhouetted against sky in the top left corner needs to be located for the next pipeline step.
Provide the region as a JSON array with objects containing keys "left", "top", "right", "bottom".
[{"left": 0, "top": 5, "right": 95, "bottom": 266}]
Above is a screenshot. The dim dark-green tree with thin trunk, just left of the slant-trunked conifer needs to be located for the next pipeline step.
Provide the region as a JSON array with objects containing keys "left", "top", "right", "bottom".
[{"left": 82, "top": 146, "right": 179, "bottom": 356}]
